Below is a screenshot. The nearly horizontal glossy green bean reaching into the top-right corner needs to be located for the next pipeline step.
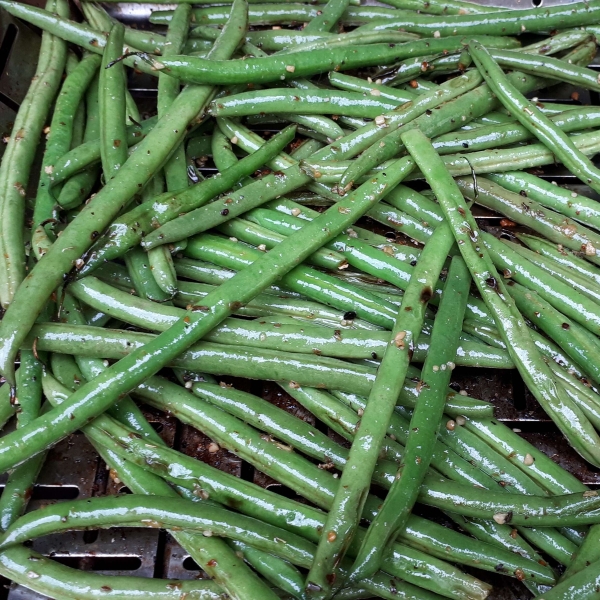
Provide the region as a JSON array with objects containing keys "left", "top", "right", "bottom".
[{"left": 360, "top": 2, "right": 599, "bottom": 36}]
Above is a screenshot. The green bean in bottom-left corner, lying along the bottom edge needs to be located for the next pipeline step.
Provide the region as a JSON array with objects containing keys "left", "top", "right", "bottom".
[{"left": 0, "top": 546, "right": 225, "bottom": 600}]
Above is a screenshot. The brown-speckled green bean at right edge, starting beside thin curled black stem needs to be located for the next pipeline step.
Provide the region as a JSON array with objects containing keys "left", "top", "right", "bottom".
[{"left": 457, "top": 177, "right": 600, "bottom": 264}]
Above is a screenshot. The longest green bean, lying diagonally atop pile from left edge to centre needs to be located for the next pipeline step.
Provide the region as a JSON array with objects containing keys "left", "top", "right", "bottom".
[{"left": 0, "top": 154, "right": 413, "bottom": 469}]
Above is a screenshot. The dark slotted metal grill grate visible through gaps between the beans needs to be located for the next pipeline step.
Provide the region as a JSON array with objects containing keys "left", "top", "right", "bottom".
[{"left": 0, "top": 0, "right": 600, "bottom": 600}]
